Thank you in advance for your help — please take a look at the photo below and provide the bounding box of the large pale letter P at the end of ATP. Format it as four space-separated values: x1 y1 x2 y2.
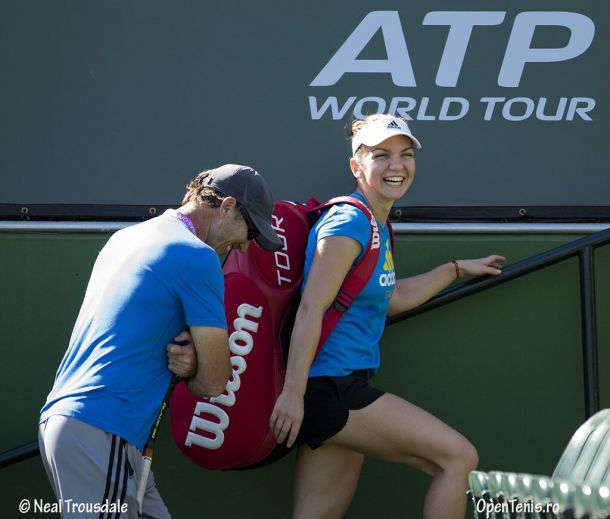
498 11 595 87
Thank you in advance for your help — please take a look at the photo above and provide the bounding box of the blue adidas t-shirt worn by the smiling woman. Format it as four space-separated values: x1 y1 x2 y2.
304 193 396 377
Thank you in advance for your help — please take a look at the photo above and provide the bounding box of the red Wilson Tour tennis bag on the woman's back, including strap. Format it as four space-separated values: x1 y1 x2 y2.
170 197 380 470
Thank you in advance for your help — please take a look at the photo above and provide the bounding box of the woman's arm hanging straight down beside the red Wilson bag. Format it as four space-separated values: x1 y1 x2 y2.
269 236 362 447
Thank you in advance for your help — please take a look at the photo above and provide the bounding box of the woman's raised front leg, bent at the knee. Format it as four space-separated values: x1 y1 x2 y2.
325 393 478 519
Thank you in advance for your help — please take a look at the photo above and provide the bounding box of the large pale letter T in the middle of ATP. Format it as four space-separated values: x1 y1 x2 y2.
423 11 506 87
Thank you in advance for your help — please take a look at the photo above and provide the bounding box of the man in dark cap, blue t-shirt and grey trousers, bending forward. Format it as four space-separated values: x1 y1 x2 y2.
39 164 281 518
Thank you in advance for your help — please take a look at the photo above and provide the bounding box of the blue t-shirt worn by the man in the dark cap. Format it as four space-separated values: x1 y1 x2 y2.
40 214 227 449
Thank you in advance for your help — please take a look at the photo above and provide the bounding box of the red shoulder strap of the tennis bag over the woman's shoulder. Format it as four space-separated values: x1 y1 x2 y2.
311 196 381 354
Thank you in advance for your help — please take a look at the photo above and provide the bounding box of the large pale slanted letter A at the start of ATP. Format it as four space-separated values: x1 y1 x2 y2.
310 11 416 87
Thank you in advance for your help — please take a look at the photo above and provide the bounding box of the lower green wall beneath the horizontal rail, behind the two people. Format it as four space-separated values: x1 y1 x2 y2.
0 233 610 519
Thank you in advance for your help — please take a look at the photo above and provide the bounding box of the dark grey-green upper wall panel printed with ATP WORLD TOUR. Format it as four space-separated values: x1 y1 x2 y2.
0 0 610 207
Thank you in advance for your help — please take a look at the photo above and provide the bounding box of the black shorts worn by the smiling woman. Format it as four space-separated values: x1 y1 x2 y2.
297 370 384 449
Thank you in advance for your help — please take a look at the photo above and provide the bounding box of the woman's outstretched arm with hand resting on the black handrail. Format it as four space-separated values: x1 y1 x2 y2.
388 254 506 315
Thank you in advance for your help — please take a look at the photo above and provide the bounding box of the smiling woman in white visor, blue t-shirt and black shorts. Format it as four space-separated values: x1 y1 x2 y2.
270 114 505 519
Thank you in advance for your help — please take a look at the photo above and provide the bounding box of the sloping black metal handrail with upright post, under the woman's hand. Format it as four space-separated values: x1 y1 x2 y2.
0 229 610 469
